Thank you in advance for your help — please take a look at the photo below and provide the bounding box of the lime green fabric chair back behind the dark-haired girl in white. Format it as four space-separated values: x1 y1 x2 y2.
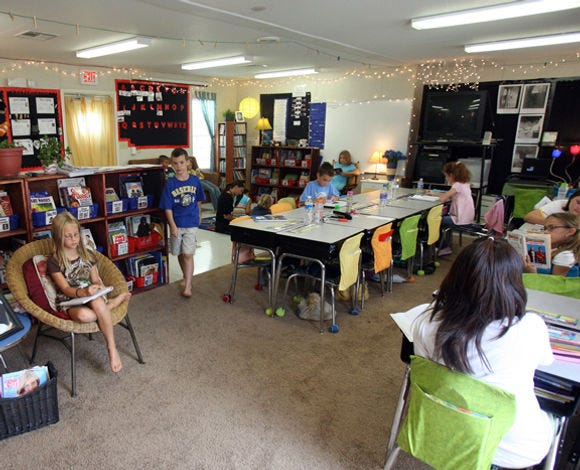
397 356 516 470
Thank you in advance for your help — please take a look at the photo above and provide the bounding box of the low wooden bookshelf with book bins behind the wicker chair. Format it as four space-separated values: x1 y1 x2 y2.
0 167 169 292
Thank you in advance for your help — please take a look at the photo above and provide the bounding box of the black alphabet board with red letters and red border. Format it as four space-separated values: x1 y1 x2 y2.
115 80 190 148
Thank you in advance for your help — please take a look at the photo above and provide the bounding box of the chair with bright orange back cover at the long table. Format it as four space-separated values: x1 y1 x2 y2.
361 223 394 310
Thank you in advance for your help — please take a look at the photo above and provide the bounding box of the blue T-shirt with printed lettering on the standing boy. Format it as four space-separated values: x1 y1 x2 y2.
159 175 205 228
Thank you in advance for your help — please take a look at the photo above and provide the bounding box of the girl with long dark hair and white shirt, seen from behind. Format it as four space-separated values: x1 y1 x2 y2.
412 238 554 468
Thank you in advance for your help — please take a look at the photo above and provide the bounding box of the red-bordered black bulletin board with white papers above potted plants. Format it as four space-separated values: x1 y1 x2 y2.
0 88 63 168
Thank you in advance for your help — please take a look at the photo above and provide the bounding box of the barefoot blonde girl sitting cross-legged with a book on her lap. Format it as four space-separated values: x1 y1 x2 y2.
47 211 131 372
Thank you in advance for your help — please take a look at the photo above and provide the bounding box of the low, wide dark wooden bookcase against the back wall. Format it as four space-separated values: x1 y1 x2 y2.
250 146 320 199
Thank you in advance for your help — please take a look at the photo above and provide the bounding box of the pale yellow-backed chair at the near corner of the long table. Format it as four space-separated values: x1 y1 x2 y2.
276 233 363 333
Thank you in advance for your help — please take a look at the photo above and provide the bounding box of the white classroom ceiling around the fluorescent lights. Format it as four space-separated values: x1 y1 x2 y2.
0 0 580 78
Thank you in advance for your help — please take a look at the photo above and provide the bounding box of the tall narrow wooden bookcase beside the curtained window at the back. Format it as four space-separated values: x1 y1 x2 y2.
215 121 248 183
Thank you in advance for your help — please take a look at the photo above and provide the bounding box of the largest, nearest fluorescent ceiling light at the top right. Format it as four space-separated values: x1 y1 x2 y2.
411 0 580 29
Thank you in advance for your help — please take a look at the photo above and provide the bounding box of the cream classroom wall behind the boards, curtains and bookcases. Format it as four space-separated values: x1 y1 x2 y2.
0 61 578 171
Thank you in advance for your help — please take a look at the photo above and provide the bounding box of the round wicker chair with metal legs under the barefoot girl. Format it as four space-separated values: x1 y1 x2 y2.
6 239 144 397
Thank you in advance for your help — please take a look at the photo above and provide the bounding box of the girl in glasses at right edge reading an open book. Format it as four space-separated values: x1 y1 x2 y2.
524 212 580 277
